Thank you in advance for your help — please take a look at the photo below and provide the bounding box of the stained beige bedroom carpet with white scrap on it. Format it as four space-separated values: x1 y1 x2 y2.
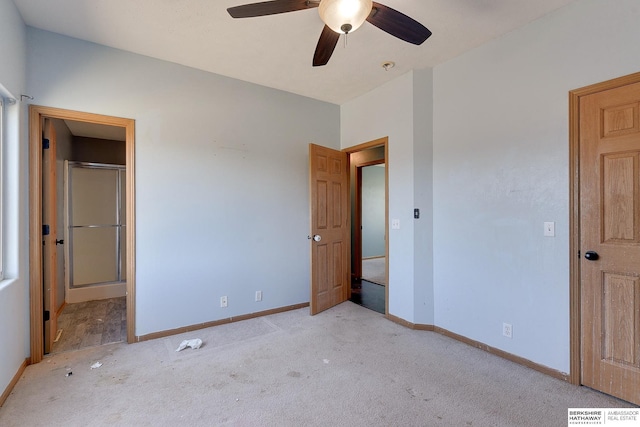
0 302 631 427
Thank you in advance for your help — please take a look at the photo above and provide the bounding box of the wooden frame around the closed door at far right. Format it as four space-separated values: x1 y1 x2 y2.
569 72 640 385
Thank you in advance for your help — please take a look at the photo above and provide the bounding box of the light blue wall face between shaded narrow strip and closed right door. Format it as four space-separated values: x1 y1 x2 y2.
434 0 640 372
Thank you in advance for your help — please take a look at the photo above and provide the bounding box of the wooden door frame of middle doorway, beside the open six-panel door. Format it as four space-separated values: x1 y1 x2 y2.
342 136 389 317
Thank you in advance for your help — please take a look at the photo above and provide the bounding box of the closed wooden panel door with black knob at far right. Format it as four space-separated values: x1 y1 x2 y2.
580 79 640 404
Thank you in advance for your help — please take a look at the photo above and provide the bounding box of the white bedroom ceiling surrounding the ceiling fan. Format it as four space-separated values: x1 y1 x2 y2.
14 0 574 104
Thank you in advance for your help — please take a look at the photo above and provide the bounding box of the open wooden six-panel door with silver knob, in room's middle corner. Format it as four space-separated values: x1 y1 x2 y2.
309 144 351 315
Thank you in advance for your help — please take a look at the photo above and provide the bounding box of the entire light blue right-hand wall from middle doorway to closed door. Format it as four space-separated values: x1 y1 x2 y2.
341 0 640 372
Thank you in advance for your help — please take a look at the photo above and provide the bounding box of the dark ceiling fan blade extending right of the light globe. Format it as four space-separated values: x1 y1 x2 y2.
367 2 431 44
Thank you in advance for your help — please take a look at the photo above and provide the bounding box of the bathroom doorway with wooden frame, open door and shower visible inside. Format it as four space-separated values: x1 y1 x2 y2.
29 106 135 363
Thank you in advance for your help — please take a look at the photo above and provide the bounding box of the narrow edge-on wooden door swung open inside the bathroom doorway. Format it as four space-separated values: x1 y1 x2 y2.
42 119 58 354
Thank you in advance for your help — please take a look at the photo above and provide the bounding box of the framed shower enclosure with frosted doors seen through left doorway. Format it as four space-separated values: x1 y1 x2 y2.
64 161 126 303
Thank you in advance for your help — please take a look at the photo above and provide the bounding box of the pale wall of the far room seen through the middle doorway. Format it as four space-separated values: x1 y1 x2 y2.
361 165 386 258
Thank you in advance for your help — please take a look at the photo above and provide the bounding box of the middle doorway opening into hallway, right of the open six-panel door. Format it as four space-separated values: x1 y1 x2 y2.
346 138 388 314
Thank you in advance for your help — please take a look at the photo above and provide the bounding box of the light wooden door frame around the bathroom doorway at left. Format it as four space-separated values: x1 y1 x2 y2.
29 105 136 364
